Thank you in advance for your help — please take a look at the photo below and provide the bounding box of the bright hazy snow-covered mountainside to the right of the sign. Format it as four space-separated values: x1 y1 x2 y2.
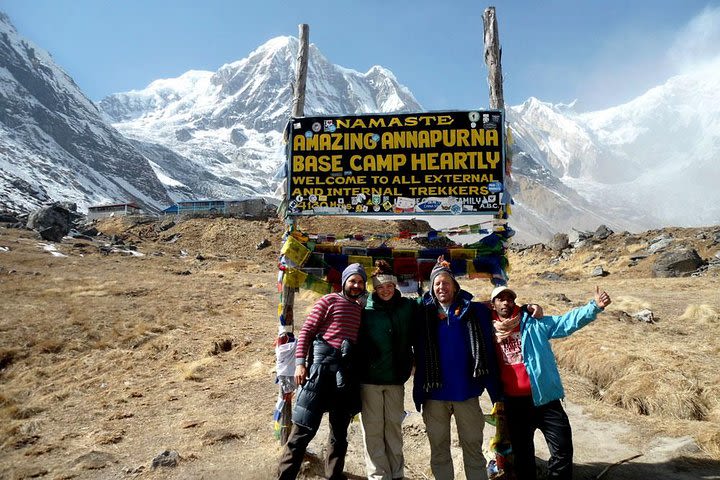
508 61 720 228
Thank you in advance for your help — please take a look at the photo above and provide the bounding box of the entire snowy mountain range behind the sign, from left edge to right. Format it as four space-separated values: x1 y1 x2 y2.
0 10 720 241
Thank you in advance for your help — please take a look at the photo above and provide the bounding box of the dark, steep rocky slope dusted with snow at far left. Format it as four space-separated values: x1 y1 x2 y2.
0 13 170 210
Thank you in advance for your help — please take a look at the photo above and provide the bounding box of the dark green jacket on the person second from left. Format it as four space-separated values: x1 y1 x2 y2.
357 290 418 385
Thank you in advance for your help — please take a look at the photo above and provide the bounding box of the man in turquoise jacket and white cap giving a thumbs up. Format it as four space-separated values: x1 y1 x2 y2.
490 286 611 480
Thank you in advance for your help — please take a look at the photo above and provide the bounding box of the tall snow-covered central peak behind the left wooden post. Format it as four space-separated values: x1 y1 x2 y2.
100 37 421 196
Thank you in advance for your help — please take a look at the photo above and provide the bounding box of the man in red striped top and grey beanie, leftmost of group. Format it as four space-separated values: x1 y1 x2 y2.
278 263 367 480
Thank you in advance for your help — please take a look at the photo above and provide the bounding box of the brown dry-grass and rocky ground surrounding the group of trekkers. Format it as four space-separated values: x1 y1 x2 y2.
0 218 720 479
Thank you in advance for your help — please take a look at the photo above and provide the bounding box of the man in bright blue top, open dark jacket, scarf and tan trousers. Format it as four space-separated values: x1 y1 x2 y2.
413 257 500 480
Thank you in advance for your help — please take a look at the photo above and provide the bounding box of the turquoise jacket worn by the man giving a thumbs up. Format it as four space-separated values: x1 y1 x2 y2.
520 300 602 406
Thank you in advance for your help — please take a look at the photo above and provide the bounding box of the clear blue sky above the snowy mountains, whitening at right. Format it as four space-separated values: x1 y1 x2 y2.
0 0 720 111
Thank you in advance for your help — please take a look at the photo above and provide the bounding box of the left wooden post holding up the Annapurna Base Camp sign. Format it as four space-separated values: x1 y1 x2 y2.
278 23 310 445
